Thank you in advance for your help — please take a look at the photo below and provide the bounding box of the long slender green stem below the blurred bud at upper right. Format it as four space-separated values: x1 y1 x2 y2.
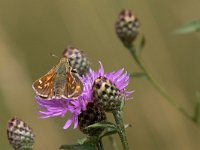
125 45 193 120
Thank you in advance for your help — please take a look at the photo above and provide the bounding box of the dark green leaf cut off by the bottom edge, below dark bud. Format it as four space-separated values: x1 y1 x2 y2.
60 144 97 150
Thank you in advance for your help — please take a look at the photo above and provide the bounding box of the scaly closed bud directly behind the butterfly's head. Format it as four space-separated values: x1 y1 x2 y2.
63 47 90 76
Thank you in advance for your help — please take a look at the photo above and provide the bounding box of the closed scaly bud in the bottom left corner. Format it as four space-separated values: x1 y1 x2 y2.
7 117 35 150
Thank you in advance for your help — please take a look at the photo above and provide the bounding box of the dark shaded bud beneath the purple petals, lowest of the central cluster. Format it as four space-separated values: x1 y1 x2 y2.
78 103 106 136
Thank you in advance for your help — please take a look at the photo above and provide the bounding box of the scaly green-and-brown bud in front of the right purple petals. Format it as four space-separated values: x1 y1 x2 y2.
92 77 123 112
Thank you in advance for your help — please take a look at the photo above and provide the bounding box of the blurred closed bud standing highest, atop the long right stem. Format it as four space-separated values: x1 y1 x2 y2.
115 9 140 45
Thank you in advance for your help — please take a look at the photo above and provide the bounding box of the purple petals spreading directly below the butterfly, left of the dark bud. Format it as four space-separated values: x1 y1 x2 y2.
35 95 89 129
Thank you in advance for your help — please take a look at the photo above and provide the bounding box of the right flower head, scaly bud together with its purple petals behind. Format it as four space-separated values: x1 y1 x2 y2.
84 63 132 112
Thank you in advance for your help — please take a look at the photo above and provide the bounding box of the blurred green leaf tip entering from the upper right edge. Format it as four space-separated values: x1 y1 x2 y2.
175 20 200 34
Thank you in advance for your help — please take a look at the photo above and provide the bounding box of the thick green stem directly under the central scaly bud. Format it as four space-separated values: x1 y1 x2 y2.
112 110 129 150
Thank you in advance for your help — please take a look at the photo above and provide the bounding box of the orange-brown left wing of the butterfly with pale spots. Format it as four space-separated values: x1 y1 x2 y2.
32 67 56 99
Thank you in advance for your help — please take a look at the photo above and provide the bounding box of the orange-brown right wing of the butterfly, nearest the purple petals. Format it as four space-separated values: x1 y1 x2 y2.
63 72 83 98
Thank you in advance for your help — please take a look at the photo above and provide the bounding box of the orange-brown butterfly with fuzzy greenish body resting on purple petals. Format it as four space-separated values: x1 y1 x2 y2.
32 57 83 100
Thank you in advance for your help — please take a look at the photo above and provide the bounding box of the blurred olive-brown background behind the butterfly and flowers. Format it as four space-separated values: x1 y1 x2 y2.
0 0 200 150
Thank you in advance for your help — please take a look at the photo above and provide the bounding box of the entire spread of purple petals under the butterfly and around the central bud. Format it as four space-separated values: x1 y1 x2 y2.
35 63 132 129
